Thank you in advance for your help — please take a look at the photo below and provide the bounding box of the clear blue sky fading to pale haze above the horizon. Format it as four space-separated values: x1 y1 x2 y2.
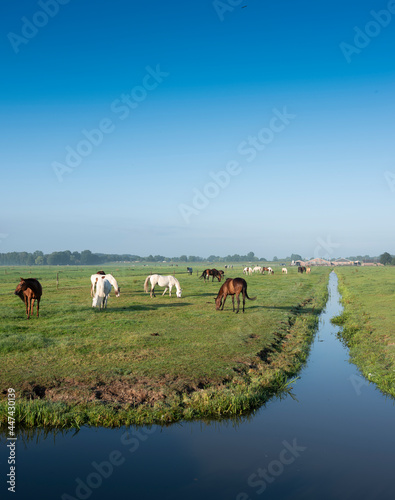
0 0 395 258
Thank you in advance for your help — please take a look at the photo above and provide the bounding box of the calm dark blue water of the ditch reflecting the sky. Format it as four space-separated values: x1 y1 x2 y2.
0 273 395 500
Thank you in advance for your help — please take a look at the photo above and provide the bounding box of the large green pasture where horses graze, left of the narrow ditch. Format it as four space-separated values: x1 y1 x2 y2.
0 266 329 427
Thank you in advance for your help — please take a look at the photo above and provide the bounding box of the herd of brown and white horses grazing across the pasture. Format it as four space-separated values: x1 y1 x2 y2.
14 266 311 319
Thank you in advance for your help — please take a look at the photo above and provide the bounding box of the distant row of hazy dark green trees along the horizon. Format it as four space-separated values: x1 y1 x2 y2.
0 250 395 266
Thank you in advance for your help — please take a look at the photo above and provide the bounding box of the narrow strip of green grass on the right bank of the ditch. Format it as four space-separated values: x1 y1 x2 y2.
332 266 395 397
